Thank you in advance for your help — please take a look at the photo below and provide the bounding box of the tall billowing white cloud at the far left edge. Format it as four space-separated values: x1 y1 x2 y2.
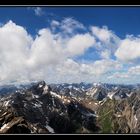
0 21 32 81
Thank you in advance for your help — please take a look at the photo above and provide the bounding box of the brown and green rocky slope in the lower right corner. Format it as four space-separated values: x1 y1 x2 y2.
98 93 140 133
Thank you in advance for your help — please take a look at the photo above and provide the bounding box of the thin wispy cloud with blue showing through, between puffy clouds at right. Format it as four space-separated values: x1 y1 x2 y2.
90 26 121 59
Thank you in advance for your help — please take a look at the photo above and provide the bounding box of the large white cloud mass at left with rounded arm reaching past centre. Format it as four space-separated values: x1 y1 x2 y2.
0 21 95 83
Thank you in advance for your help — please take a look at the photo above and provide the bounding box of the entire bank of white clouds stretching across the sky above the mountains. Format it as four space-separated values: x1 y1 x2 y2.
0 18 140 84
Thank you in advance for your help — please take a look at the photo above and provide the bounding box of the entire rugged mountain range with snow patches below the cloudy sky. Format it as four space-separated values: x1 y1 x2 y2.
0 81 140 134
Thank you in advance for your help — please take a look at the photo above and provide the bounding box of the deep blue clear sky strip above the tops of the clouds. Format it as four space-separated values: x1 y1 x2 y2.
0 7 140 37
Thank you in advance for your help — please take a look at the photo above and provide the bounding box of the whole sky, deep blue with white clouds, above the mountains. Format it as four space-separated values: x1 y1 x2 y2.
0 7 140 84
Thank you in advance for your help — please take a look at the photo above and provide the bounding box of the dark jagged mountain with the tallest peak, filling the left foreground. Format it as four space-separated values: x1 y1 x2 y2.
0 81 99 134
